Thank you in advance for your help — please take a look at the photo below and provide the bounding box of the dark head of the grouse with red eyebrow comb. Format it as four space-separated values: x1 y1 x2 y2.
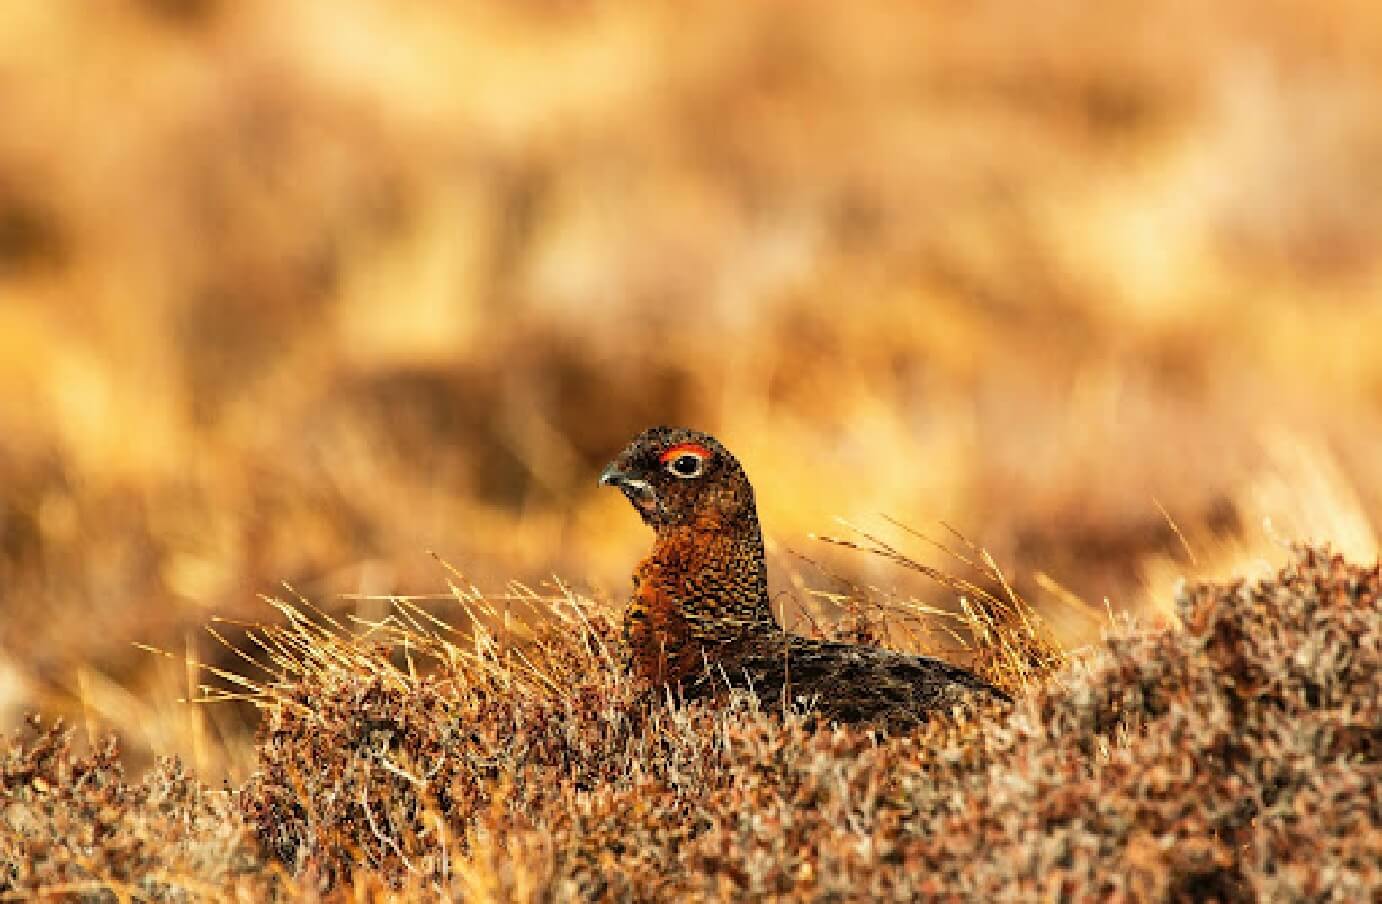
600 427 756 531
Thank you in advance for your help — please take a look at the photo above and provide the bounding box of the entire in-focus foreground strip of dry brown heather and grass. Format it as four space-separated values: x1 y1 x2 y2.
0 550 1382 901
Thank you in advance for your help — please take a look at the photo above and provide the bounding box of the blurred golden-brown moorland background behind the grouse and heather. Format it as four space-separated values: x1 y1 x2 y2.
0 0 1382 774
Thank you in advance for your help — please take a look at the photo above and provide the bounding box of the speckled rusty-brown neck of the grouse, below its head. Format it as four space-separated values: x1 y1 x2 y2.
650 513 781 644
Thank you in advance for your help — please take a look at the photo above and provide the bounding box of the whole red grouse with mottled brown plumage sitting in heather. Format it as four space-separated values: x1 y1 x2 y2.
600 427 1006 727
